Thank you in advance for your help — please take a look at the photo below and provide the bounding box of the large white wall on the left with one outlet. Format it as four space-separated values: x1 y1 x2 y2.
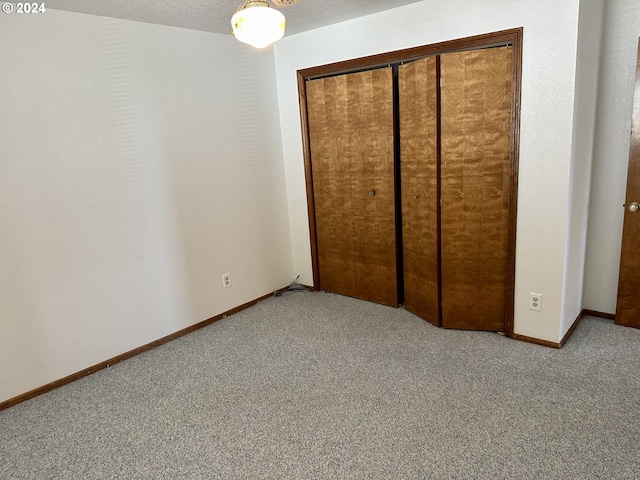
0 10 293 401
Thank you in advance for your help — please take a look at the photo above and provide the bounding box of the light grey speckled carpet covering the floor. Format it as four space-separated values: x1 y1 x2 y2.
0 292 640 479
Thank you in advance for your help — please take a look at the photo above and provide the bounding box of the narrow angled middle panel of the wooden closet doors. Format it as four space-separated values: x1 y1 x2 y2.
398 57 440 325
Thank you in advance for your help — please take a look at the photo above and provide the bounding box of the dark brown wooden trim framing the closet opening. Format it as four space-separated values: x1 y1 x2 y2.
297 27 523 337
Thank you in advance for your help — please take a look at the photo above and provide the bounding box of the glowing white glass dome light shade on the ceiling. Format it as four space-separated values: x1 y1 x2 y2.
231 0 285 48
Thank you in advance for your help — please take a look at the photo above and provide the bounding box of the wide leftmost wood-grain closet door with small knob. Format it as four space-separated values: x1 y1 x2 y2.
306 68 398 306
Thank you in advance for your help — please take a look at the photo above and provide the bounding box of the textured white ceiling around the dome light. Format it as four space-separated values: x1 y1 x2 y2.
46 0 420 35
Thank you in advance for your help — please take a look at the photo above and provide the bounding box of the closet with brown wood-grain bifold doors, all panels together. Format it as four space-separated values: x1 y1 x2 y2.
299 30 521 333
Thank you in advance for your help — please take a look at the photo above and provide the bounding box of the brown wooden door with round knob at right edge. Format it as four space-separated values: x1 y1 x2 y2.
616 41 640 328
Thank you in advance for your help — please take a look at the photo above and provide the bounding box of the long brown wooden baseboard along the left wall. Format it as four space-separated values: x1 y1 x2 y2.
0 292 275 411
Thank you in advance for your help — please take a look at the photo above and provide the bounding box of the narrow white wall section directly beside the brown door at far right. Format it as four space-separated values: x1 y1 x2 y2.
583 0 640 313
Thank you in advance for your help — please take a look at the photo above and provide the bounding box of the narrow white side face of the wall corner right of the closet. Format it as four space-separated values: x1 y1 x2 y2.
560 0 604 338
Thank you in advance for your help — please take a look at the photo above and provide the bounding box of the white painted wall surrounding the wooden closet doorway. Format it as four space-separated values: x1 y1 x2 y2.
275 0 579 342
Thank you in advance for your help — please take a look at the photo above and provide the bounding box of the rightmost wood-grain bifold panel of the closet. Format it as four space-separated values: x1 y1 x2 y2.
441 47 512 331
